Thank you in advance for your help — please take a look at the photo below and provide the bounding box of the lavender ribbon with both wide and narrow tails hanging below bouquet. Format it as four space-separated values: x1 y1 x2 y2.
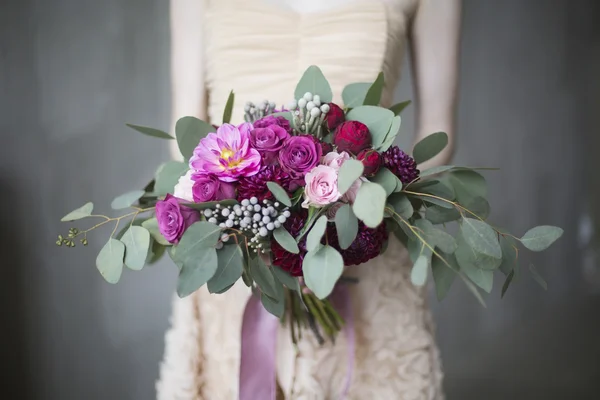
239 284 355 400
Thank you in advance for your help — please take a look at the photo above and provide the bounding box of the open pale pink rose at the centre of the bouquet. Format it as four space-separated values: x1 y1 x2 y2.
302 165 341 208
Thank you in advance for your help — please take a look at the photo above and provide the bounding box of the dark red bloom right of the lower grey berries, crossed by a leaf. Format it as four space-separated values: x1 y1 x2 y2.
271 208 308 276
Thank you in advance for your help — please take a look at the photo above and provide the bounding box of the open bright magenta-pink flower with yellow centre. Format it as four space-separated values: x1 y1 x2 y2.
190 123 261 182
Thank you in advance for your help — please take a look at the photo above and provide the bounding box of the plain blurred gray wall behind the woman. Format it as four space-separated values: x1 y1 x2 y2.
0 0 600 400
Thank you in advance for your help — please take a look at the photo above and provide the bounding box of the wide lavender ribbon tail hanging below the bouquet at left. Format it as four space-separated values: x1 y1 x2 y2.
239 294 279 400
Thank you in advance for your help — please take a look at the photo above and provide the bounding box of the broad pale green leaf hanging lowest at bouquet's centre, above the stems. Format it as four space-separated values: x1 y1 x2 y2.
302 246 344 299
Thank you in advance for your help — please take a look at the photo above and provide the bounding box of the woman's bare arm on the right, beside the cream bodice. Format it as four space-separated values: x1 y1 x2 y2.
410 0 461 169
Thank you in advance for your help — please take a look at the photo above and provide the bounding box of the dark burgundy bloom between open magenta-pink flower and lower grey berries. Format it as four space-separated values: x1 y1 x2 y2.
237 165 296 201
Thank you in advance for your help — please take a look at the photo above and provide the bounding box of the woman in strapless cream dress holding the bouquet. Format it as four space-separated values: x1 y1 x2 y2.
157 0 460 400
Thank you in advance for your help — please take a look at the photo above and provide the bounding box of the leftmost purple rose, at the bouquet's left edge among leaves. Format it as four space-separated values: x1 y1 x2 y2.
156 194 200 243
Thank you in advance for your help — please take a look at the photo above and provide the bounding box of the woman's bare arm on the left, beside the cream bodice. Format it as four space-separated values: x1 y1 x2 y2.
170 0 206 159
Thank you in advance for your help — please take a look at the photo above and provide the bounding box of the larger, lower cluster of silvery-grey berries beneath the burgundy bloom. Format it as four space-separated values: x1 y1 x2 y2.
204 197 291 252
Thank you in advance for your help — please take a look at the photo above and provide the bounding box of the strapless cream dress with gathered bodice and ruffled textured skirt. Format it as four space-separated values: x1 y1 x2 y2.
157 0 443 400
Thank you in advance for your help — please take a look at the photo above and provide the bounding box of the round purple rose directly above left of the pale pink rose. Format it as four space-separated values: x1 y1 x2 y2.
279 135 323 180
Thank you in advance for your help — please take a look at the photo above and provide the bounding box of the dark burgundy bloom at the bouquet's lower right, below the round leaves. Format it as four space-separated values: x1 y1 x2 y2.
327 222 388 266
